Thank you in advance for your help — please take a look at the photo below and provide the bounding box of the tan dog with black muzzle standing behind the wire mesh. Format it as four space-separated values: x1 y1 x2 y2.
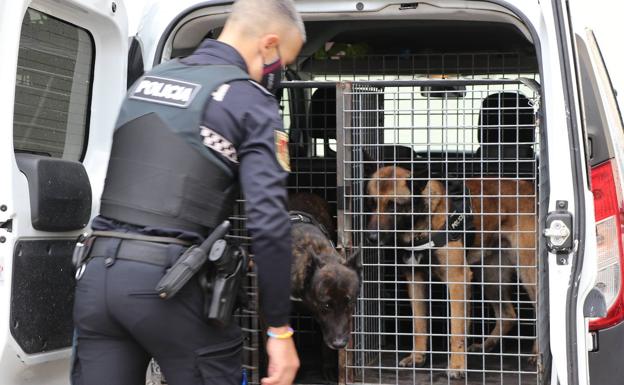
367 166 537 379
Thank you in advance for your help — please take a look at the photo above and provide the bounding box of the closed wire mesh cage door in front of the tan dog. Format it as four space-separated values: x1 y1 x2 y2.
337 79 544 385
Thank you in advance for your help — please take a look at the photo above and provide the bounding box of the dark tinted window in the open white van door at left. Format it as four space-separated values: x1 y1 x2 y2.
13 9 94 161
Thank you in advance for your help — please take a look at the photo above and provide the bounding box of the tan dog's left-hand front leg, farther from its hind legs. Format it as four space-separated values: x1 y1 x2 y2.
399 270 429 367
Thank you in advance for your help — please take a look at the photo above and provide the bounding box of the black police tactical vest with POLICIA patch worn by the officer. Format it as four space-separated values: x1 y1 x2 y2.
100 60 249 236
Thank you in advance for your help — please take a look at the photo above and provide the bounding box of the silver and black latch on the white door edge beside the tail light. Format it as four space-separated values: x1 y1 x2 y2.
543 201 573 265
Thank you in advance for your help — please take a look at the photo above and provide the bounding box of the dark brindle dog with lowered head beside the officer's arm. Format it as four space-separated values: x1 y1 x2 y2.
288 193 361 350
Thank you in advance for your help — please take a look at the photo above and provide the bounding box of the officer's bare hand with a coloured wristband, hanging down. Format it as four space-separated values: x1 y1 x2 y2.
262 328 299 385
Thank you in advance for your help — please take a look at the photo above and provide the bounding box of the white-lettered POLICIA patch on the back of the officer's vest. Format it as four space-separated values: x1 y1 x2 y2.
130 76 201 108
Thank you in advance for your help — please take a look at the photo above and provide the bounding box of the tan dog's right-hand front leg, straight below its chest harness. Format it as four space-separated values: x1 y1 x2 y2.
437 241 472 379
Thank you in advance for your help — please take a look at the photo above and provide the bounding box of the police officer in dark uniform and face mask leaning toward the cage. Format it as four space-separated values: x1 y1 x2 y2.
72 0 305 385
